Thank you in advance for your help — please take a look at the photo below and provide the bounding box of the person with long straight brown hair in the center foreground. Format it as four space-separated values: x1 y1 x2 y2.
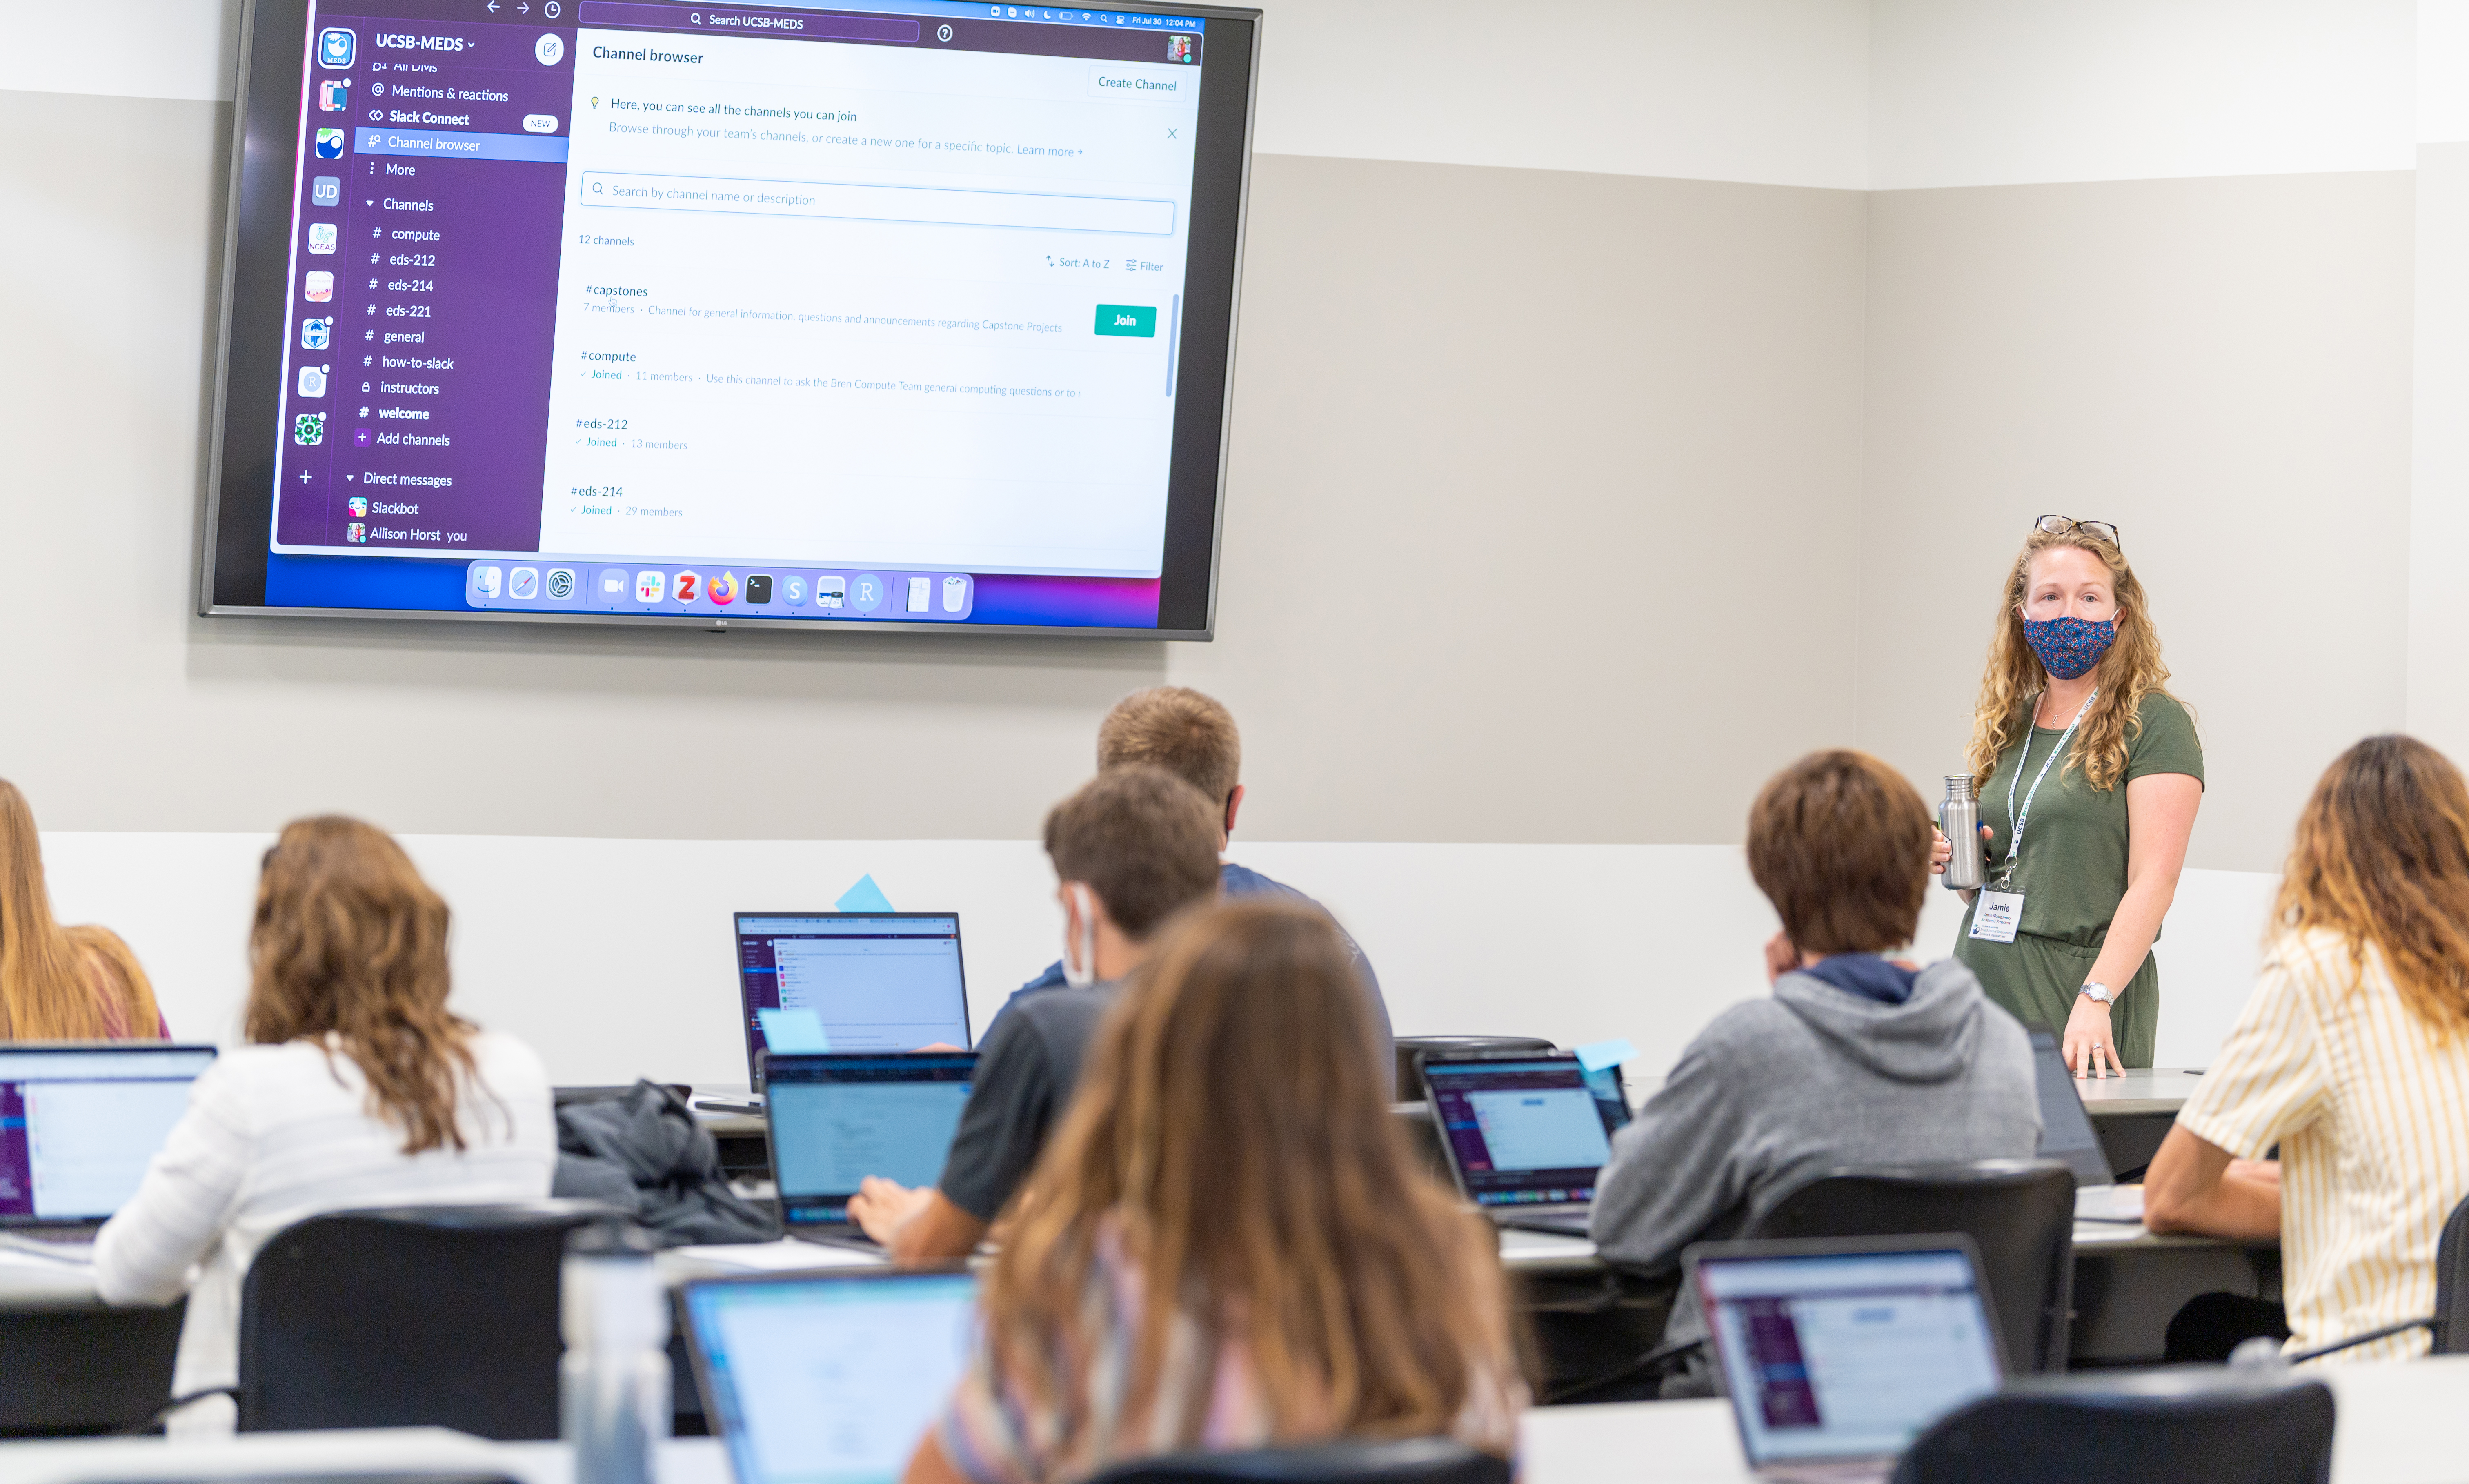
909 899 1526 1484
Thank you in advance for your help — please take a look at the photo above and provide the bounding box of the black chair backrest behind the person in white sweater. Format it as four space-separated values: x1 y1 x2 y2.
240 1200 622 1440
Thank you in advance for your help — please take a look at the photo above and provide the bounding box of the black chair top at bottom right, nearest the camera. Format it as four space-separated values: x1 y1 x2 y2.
1894 1366 2333 1484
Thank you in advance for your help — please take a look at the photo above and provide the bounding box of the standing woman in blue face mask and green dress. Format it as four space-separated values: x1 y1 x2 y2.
1941 516 2202 1077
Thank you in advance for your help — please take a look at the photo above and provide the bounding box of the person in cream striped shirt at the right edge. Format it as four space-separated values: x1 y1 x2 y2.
2143 736 2469 1361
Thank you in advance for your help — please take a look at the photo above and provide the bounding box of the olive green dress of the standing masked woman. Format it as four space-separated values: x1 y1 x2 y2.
1955 694 2202 1067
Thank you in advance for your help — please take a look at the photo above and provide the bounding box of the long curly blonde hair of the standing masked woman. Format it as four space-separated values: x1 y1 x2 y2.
1963 528 2168 792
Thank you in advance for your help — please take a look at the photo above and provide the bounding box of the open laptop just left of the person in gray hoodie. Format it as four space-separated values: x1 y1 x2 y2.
1422 1052 1630 1237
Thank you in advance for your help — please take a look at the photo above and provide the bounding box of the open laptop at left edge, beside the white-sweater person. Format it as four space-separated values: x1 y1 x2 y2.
0 1042 215 1242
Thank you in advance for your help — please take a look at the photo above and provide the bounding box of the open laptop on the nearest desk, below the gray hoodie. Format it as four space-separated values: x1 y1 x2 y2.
1682 1235 2005 1479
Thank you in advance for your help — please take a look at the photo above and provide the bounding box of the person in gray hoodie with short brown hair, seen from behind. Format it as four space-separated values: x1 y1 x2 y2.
1593 751 2040 1395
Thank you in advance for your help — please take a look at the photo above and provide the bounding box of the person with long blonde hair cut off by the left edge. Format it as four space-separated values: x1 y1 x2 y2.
0 778 163 1042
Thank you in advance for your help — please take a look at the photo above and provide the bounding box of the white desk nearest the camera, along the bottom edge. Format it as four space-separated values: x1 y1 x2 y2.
0 1355 2469 1484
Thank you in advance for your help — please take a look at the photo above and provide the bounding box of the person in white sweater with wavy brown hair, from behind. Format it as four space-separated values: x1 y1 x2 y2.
94 817 558 1435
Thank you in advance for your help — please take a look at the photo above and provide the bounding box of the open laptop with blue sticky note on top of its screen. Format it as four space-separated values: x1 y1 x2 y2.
736 911 973 1106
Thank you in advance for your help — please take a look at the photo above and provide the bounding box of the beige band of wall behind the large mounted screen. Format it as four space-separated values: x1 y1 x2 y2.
0 94 1864 842
